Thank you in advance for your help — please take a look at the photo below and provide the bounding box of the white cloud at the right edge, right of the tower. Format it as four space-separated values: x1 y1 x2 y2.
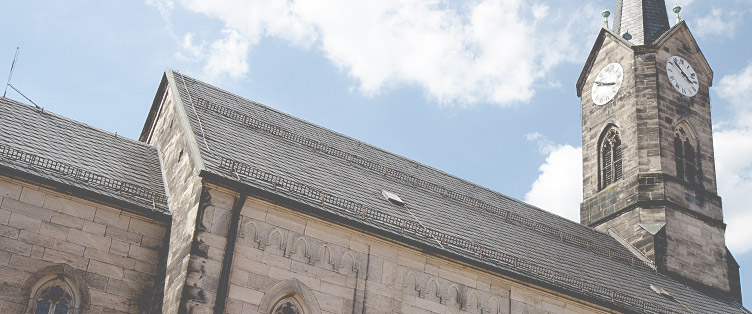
713 63 752 254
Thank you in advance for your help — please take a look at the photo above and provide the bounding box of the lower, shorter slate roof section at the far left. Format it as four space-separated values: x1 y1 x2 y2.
0 98 169 218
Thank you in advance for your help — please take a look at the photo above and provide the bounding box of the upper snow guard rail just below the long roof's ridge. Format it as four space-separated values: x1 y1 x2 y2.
196 98 654 271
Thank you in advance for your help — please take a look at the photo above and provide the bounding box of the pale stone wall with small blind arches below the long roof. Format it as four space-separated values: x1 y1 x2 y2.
217 194 602 314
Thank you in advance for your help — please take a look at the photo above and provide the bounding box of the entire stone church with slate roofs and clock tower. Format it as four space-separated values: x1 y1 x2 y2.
0 0 750 314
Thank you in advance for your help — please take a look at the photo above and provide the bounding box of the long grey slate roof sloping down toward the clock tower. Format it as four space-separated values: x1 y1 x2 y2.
166 71 749 313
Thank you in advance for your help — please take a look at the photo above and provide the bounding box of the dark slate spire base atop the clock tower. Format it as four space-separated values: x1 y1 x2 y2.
614 0 671 45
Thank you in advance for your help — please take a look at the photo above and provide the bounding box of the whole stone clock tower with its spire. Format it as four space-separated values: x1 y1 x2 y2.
577 0 741 299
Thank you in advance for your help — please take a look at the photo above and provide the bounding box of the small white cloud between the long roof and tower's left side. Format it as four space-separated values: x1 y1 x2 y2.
525 133 582 222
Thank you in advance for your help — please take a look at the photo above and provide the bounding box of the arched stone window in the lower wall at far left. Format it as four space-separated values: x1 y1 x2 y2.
22 264 89 314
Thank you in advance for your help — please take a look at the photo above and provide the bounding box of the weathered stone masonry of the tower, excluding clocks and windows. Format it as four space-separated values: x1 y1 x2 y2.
580 25 729 291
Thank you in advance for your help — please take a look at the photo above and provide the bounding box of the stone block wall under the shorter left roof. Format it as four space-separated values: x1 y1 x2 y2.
0 177 165 313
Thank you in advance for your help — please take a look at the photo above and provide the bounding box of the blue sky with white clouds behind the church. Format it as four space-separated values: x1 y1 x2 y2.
0 0 752 300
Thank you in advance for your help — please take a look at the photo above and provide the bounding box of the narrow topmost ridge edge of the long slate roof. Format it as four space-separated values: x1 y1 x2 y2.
177 73 600 232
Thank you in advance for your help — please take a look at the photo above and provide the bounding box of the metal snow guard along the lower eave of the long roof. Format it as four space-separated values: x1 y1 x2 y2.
220 156 679 314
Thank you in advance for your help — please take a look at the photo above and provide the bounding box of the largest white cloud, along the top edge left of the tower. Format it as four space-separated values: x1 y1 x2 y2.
156 0 600 106
